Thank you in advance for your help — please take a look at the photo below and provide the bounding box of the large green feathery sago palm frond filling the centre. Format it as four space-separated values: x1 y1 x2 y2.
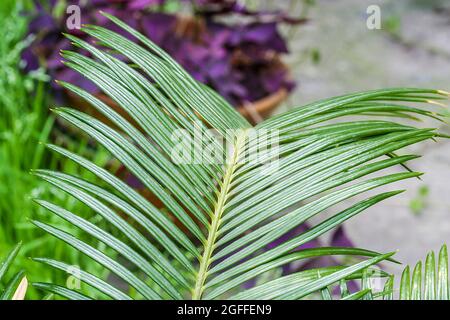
29 14 447 299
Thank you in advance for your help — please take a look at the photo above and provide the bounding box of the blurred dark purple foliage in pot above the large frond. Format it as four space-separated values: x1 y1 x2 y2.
23 0 303 105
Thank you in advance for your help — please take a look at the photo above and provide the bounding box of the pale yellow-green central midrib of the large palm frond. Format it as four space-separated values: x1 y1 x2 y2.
192 132 246 300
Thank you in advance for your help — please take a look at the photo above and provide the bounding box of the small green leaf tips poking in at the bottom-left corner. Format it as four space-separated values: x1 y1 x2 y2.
0 243 28 300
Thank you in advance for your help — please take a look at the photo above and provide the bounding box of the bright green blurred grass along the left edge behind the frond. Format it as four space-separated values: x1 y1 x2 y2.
0 1 116 298
